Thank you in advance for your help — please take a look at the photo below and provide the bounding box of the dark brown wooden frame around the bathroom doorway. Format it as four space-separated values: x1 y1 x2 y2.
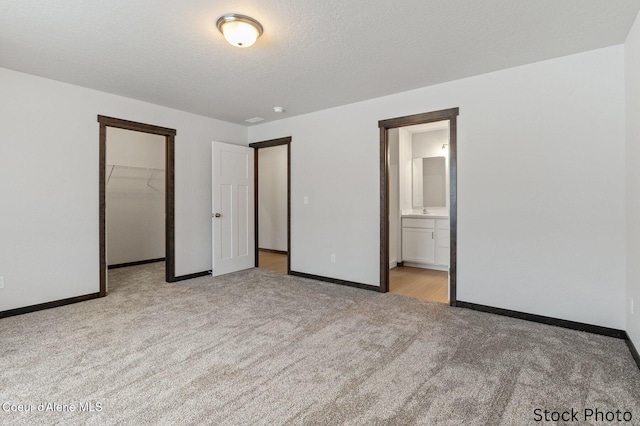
378 108 459 306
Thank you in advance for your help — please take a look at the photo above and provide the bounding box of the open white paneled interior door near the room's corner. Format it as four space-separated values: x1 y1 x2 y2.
211 142 255 276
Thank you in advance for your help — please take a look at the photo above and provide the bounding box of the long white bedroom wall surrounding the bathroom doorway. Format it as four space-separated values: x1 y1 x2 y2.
249 46 625 329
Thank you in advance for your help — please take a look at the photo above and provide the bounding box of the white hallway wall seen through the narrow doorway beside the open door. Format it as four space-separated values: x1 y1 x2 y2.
258 145 288 251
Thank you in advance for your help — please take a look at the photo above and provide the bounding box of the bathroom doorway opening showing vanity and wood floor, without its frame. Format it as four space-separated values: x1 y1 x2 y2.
388 120 450 303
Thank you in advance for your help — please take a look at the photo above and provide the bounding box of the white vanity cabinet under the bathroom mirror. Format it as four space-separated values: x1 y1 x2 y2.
402 217 449 270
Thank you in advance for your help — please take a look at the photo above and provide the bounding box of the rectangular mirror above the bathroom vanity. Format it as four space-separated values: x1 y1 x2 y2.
413 157 447 208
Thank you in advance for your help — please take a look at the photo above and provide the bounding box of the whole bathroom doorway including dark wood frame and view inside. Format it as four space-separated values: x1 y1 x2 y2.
379 108 458 306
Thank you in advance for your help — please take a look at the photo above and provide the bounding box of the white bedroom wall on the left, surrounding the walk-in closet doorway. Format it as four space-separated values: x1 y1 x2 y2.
0 69 247 311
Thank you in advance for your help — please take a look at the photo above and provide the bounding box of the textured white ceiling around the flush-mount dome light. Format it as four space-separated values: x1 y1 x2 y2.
0 0 640 124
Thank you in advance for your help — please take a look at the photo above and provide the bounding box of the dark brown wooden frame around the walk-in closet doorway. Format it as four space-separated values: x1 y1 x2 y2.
98 115 176 297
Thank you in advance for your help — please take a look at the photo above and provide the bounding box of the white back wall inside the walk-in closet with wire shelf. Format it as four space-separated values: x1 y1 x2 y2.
106 127 165 265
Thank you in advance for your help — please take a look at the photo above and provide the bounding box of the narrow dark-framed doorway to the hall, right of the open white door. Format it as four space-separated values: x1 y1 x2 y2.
249 137 291 274
